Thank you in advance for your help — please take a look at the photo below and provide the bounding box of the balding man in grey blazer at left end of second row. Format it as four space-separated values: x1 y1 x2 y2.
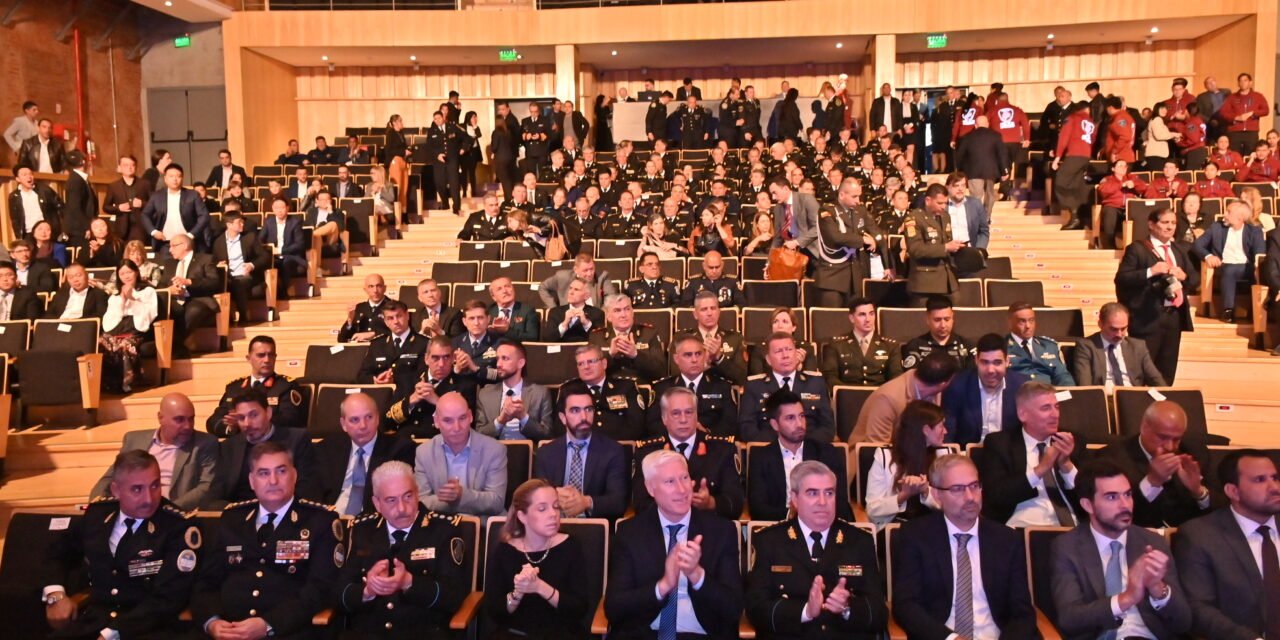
90 393 221 511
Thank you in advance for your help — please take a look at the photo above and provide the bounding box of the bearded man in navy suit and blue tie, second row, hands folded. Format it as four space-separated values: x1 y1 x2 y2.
534 383 630 520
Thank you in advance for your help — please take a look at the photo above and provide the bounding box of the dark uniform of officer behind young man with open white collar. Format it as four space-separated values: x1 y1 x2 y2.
737 370 836 443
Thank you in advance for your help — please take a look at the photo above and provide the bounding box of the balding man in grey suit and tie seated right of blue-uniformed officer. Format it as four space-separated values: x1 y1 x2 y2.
1071 302 1166 387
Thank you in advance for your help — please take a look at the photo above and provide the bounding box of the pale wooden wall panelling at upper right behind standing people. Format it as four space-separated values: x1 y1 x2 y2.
893 40 1199 111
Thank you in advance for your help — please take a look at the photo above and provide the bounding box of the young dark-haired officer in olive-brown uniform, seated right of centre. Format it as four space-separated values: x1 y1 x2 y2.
822 297 902 387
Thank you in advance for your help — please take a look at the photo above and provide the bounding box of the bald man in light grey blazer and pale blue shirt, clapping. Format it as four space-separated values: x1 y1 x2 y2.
413 392 507 516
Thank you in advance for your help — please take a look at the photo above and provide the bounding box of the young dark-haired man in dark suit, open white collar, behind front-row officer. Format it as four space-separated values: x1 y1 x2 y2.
746 390 854 521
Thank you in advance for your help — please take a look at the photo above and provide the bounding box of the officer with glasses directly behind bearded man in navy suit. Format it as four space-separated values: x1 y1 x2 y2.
556 344 645 440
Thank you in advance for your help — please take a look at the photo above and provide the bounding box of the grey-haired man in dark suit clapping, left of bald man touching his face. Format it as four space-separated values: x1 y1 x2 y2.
982 381 1085 527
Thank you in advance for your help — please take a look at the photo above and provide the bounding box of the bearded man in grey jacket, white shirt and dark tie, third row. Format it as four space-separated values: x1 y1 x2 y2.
476 338 552 440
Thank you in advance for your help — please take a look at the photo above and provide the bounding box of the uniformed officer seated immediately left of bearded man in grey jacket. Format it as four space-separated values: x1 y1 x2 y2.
383 337 476 438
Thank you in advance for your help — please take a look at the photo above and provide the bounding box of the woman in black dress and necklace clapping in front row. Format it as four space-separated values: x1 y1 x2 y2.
484 479 589 640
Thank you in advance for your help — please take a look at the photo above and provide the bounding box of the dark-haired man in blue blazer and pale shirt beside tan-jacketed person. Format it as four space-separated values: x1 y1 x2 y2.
942 333 1029 448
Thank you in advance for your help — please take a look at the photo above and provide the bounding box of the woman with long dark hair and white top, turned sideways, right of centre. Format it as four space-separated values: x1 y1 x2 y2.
865 401 947 531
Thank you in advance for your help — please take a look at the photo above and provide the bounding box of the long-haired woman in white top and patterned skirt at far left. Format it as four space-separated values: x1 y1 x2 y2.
99 260 160 393
